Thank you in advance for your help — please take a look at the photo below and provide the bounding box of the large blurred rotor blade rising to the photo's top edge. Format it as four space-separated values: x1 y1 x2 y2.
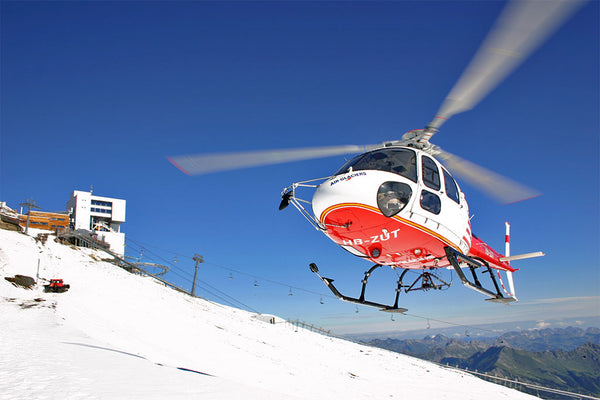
428 0 585 132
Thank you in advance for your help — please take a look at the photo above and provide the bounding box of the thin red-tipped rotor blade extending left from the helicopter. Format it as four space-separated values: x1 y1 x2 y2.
167 145 380 175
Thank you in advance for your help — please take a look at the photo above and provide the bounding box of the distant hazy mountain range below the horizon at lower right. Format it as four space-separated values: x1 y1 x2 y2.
369 327 600 396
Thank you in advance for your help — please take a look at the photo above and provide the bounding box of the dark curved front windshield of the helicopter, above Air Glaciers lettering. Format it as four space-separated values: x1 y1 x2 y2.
335 148 417 182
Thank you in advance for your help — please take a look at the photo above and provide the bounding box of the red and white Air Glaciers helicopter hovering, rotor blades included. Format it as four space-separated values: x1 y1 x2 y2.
168 0 584 313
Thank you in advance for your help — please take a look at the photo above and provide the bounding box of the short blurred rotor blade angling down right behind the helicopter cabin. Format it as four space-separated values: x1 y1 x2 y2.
438 149 541 204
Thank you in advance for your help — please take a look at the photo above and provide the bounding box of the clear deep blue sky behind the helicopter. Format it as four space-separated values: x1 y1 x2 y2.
0 1 600 333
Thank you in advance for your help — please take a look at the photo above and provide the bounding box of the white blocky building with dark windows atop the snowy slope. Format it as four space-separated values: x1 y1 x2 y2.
67 190 126 255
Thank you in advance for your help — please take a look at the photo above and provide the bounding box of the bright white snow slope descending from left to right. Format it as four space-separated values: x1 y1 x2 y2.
0 229 532 400
